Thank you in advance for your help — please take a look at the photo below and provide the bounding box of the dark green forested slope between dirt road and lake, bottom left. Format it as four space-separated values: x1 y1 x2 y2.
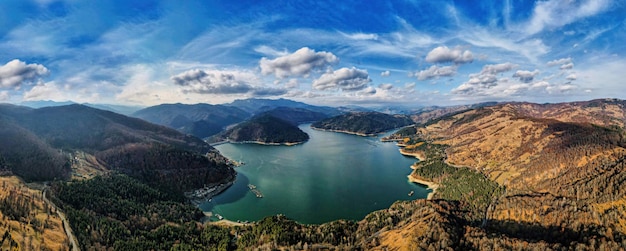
51 175 210 250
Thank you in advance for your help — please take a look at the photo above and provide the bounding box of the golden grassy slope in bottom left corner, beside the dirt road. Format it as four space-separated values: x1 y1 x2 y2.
0 176 70 250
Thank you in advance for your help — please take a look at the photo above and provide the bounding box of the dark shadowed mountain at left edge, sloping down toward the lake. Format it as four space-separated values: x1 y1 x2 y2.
0 104 235 191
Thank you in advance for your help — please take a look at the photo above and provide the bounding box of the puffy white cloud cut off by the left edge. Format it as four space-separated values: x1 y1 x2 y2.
0 59 48 88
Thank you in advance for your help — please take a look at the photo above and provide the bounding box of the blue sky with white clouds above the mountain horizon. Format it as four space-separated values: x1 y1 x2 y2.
0 0 626 106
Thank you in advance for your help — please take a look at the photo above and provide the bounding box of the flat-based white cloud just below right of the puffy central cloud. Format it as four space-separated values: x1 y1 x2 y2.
313 67 371 91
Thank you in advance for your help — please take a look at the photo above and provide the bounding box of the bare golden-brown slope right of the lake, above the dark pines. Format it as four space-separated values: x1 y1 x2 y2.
418 102 626 192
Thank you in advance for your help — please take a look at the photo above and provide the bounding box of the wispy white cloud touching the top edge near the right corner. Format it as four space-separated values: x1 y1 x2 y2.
522 0 611 35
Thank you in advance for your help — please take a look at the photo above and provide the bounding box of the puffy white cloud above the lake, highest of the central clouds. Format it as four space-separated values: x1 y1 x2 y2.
259 47 339 78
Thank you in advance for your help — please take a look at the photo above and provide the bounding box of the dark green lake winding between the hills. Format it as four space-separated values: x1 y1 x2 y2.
200 124 429 224
